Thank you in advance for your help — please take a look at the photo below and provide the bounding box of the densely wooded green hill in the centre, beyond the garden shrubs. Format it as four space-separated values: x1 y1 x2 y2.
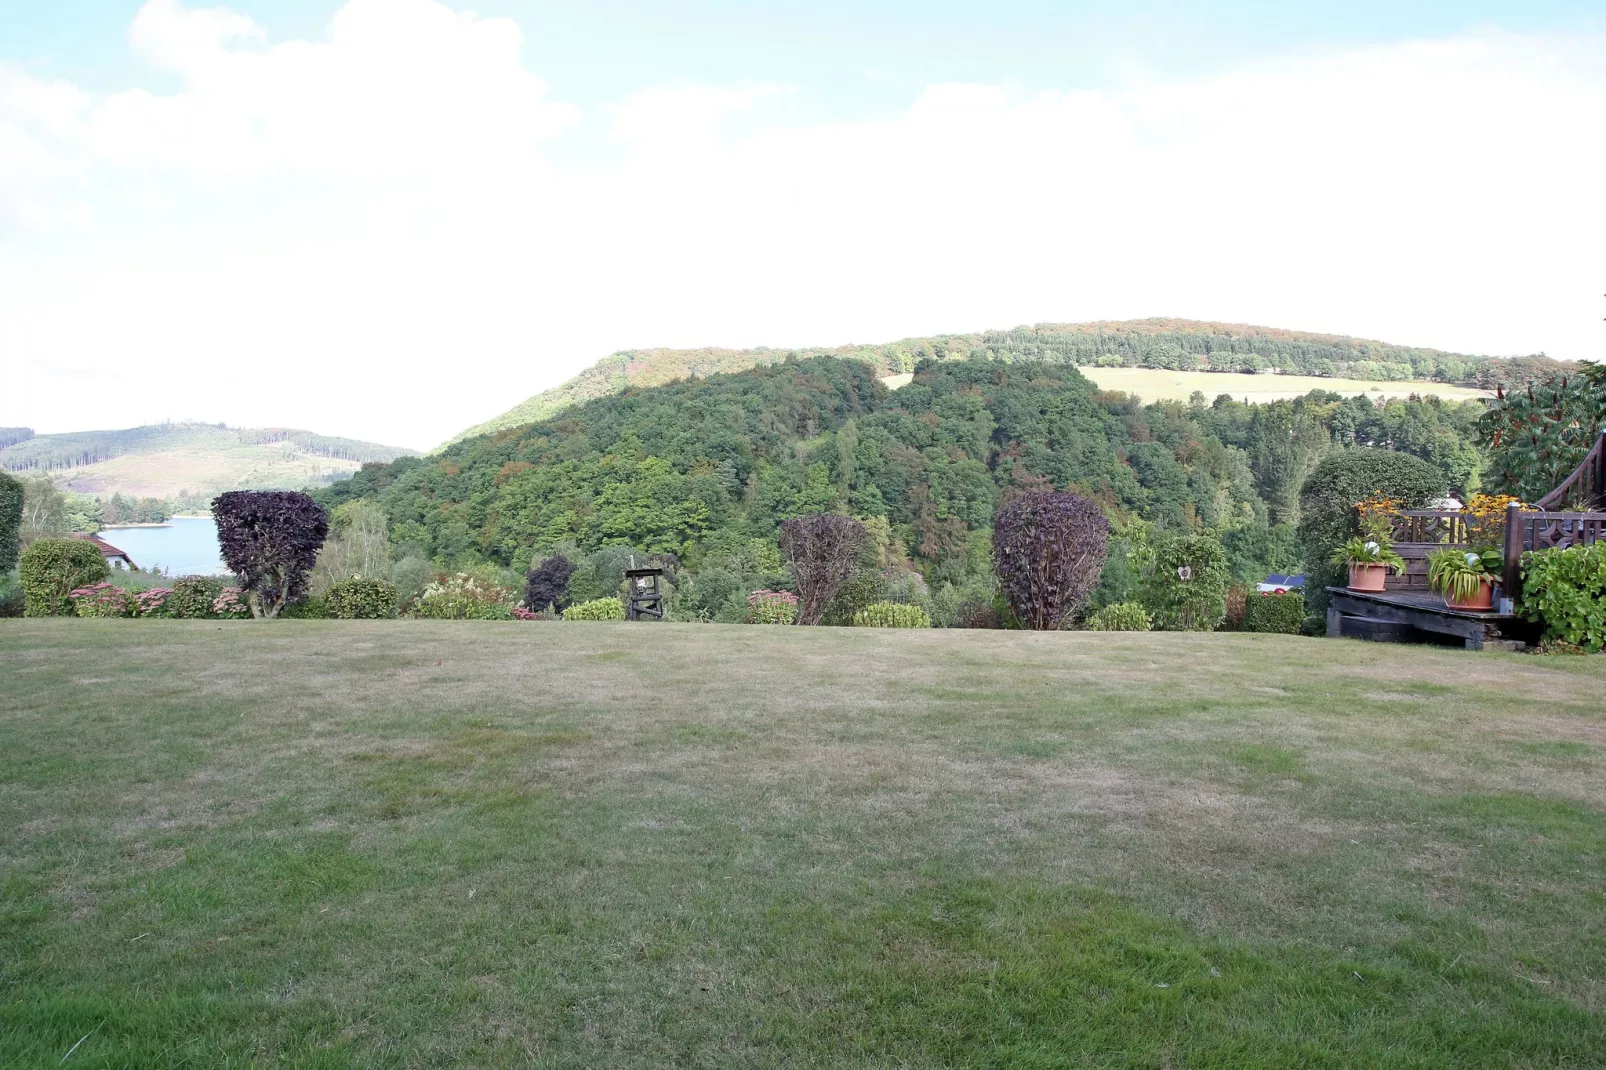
329 357 1482 582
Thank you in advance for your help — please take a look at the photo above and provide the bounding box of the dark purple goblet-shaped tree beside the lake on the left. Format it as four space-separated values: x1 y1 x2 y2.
212 490 329 619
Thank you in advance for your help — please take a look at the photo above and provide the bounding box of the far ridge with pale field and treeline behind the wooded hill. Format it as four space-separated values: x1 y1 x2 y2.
453 320 1556 442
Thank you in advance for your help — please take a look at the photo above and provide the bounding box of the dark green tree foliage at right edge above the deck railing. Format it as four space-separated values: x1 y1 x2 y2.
1478 365 1606 504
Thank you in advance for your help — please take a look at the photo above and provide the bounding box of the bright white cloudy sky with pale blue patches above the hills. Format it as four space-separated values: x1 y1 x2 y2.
0 0 1606 447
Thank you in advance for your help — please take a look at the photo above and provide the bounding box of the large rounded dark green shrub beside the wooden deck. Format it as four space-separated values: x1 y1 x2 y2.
1299 447 1449 617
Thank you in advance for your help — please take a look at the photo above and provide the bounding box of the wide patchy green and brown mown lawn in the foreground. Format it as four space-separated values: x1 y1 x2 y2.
0 620 1606 1070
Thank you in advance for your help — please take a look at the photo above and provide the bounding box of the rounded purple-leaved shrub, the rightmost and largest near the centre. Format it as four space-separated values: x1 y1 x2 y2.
993 490 1110 631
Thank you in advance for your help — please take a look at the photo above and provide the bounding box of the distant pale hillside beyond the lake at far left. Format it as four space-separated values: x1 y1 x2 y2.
0 424 413 498
